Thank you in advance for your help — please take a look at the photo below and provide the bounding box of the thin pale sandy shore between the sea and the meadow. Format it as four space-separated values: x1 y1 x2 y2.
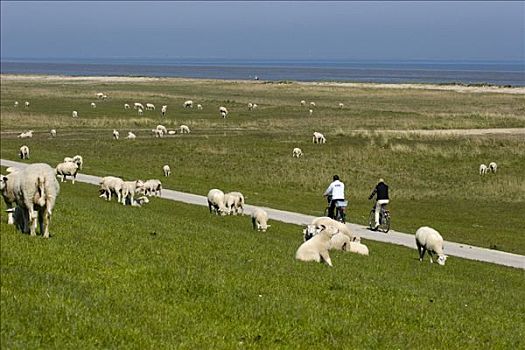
0 74 525 95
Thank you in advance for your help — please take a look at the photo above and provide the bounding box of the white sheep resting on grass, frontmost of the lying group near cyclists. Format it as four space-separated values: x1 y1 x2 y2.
295 225 339 267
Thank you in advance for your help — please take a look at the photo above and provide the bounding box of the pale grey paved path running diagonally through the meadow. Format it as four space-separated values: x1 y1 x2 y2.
0 159 525 269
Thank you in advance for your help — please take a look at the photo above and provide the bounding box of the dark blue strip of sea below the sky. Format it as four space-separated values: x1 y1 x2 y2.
0 58 525 86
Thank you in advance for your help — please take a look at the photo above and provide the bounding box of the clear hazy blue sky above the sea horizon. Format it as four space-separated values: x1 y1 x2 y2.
0 0 525 61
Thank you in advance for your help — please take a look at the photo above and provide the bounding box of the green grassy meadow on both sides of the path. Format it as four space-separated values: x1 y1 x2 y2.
0 79 525 349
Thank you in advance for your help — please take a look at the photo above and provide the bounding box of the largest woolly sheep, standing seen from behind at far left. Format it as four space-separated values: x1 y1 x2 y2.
14 163 60 238
